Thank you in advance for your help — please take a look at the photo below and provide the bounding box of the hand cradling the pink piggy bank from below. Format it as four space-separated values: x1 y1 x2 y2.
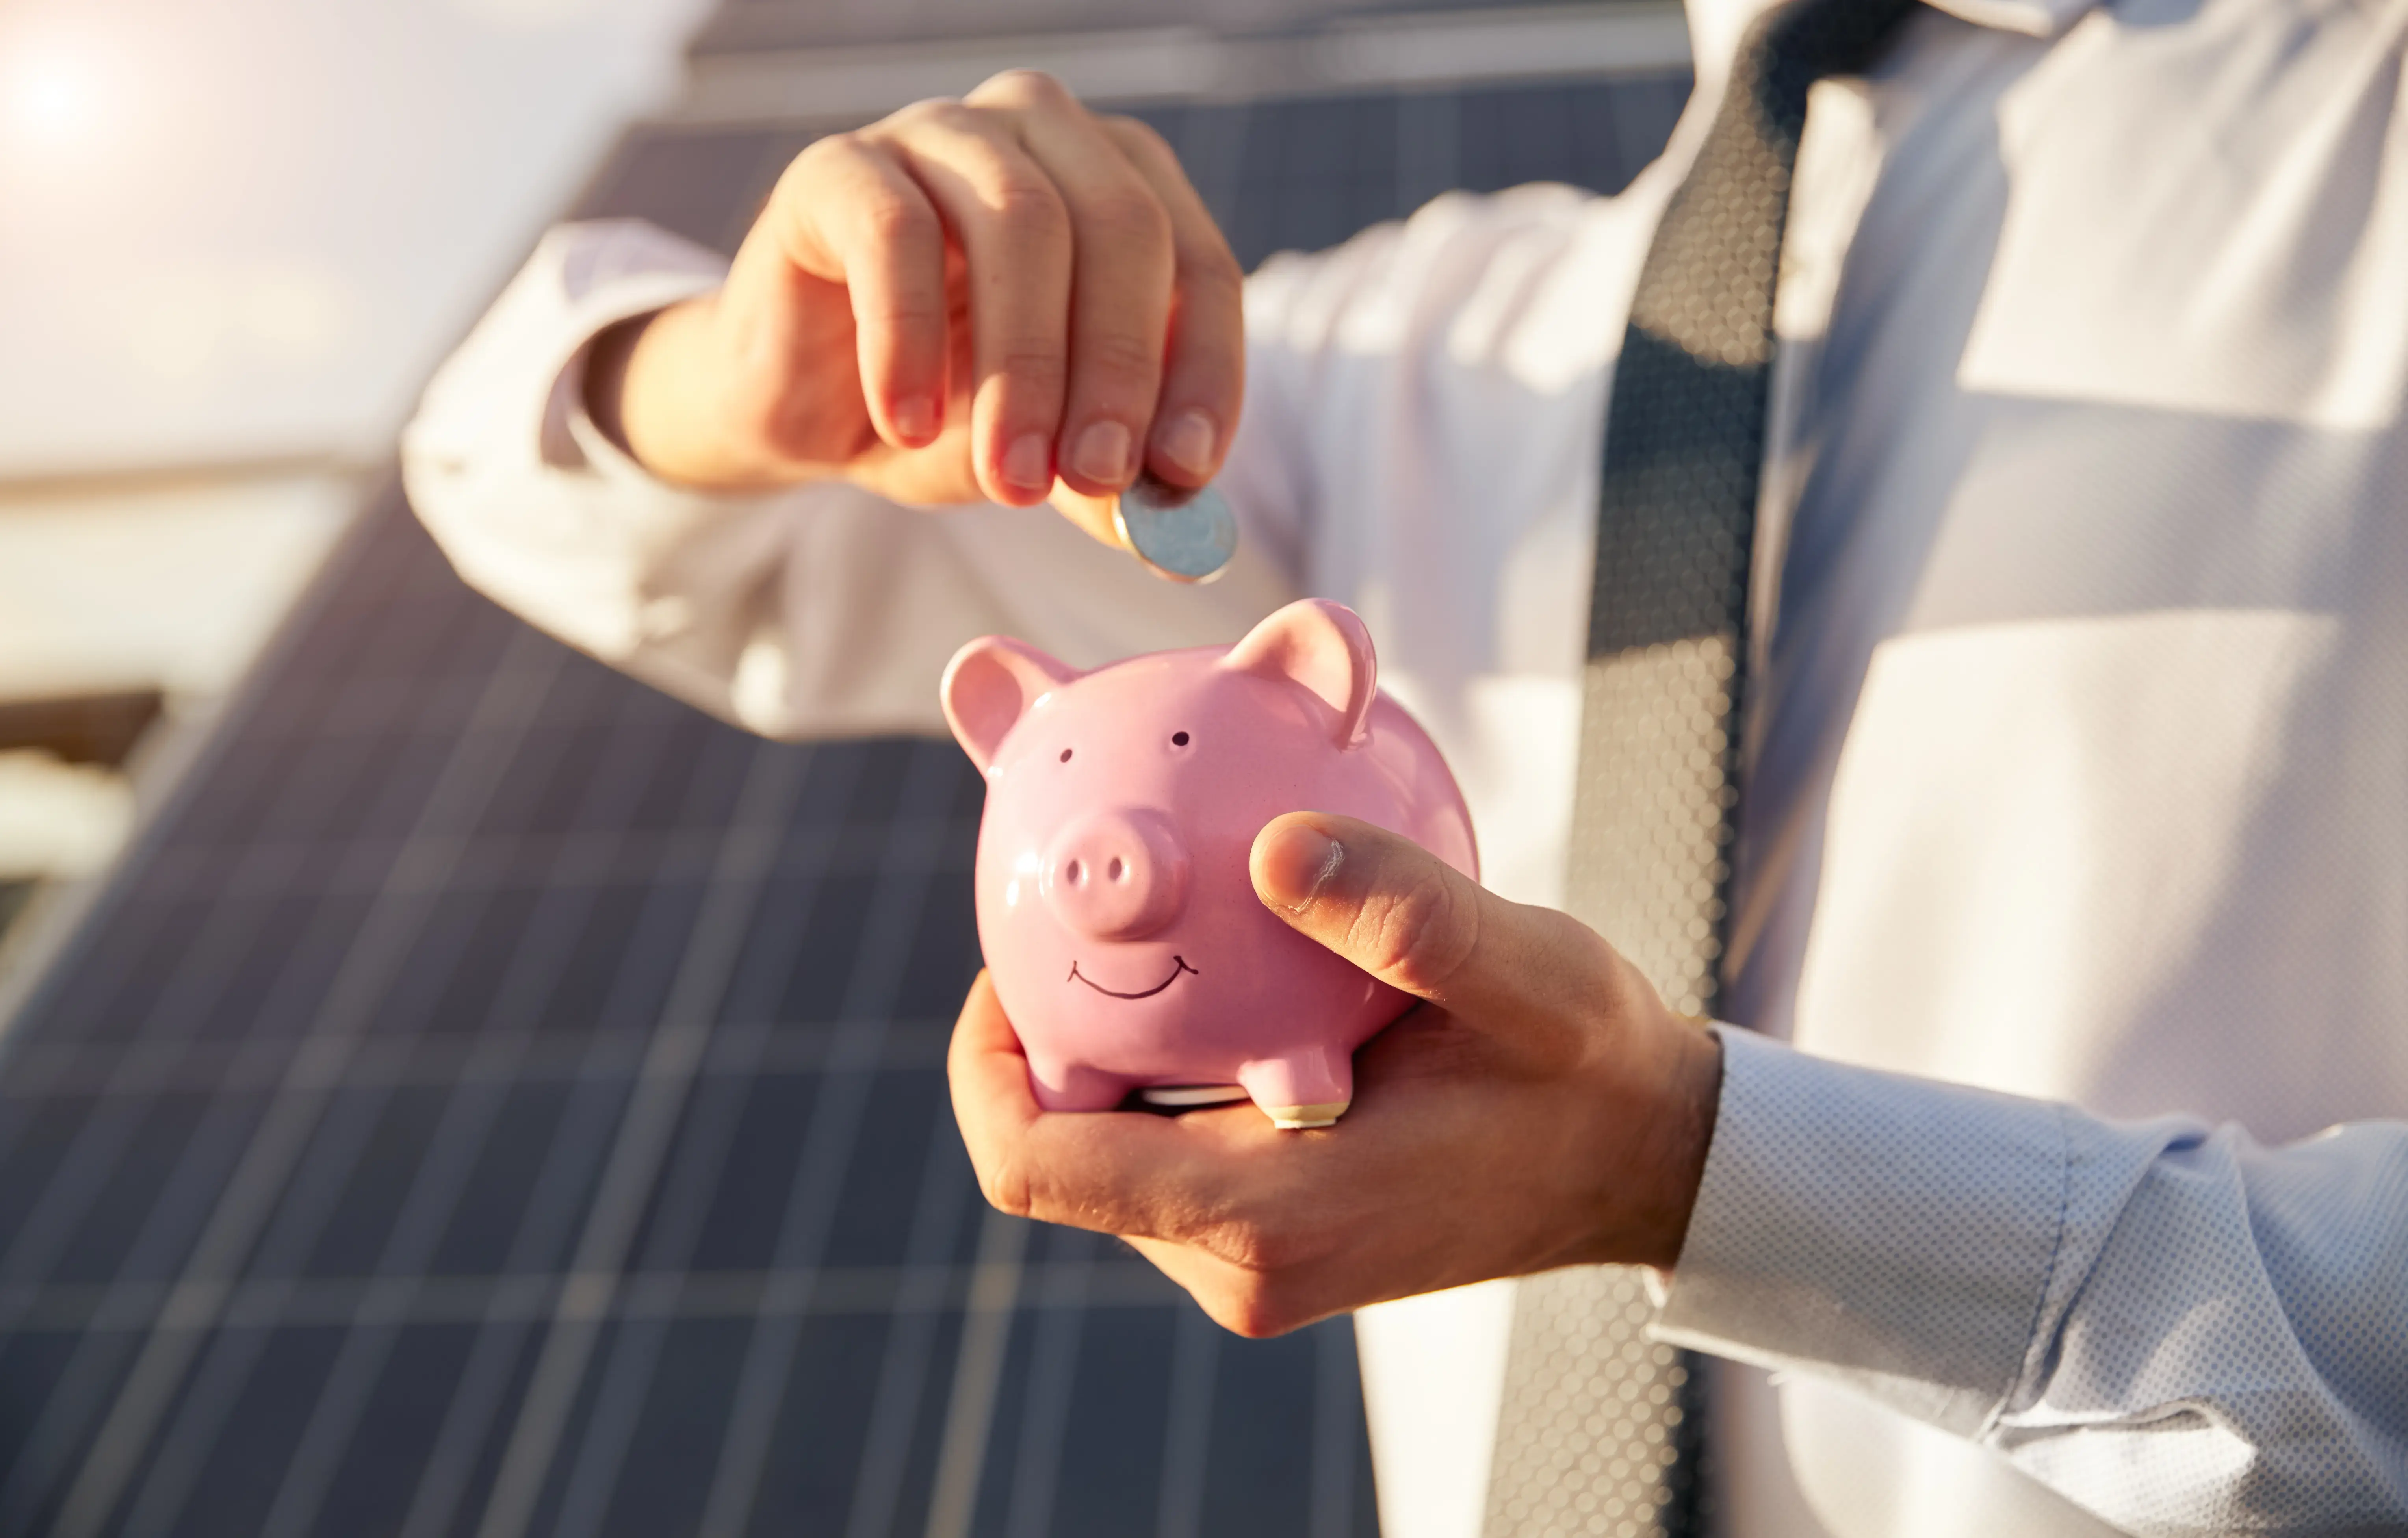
949 811 1722 1336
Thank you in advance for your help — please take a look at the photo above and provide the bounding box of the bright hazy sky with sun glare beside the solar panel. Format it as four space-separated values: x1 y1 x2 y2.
0 0 708 481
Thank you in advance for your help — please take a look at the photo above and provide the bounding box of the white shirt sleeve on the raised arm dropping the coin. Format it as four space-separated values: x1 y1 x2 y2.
402 219 1298 737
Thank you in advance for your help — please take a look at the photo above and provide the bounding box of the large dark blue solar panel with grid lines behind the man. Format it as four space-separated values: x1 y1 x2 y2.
0 57 1686 1538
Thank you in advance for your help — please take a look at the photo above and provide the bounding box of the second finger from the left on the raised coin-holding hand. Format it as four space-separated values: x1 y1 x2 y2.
889 101 1071 508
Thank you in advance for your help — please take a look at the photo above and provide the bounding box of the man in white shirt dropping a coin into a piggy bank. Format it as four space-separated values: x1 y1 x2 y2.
409 0 2408 1533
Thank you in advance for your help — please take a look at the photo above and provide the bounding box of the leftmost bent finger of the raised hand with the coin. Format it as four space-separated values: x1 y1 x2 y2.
761 135 949 448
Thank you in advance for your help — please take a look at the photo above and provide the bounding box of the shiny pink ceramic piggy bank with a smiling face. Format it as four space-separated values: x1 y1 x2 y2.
944 599 1478 1126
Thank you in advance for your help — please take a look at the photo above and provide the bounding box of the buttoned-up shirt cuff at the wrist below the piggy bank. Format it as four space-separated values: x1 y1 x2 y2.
1654 1028 2068 1434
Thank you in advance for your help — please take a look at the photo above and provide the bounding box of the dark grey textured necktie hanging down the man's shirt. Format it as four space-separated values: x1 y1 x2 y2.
1488 0 1914 1538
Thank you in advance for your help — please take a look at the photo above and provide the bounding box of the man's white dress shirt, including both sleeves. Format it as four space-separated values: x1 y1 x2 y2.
405 0 2408 1538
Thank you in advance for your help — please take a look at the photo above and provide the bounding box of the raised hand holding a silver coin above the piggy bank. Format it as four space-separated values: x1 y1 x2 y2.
588 70 1245 539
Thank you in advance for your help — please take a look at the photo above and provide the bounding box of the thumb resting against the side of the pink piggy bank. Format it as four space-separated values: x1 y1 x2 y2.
1250 811 1539 1016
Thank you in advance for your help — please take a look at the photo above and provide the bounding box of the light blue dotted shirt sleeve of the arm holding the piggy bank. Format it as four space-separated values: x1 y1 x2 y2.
1657 1030 2408 1536
